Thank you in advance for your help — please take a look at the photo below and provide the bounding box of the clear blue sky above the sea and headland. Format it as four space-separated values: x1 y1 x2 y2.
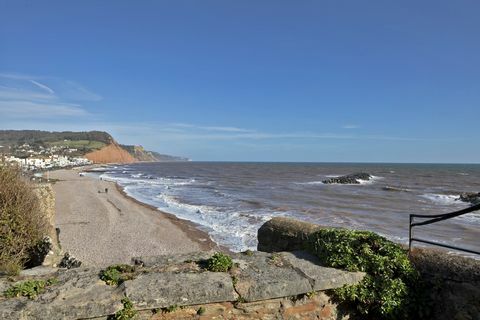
0 0 480 163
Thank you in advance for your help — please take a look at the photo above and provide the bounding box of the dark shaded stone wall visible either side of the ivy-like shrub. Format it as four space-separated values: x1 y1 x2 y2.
258 218 480 320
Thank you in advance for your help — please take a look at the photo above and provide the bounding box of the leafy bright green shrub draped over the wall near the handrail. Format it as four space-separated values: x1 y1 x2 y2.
309 229 418 319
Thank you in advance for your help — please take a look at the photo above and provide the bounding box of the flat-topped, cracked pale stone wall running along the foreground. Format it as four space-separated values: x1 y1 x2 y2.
0 251 365 320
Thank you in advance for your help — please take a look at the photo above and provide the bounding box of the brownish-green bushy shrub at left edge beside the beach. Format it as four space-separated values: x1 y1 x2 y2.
0 164 47 274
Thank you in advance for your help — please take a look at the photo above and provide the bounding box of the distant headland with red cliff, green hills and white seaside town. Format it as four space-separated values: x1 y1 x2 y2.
0 130 189 170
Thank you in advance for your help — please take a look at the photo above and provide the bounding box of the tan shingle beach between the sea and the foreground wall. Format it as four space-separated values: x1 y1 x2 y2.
50 170 217 266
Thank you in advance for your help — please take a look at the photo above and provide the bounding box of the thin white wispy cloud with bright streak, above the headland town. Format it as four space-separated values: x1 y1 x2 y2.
0 73 102 120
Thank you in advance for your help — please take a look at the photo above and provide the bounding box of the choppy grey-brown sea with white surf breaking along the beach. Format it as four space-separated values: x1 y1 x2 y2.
87 162 480 255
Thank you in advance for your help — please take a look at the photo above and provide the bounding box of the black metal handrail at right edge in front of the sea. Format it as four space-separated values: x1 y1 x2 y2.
408 203 480 255
